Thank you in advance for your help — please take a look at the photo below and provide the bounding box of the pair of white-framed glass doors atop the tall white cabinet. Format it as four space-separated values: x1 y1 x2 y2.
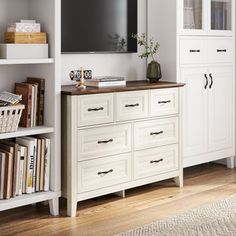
179 0 234 36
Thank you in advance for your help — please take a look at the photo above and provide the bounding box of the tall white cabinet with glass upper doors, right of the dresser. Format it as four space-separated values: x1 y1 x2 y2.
147 0 235 168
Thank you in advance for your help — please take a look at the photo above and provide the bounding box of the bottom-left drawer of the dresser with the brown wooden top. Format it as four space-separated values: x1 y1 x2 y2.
77 154 131 193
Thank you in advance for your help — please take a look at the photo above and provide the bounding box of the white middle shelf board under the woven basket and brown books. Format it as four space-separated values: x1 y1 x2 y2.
0 126 54 140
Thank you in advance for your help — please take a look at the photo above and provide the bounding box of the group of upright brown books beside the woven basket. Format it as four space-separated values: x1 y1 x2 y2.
15 78 45 128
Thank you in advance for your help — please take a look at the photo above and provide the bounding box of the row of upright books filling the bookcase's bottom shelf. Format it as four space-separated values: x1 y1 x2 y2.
0 137 51 199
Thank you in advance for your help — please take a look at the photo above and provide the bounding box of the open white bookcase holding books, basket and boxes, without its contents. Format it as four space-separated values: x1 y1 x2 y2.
0 0 61 215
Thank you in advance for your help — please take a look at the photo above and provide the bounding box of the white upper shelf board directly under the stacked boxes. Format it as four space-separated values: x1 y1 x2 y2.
0 58 54 65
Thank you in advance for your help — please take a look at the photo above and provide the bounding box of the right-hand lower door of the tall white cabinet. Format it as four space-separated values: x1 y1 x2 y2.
209 66 233 151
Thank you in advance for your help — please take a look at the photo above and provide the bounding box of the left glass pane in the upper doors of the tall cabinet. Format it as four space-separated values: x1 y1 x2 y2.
183 0 204 30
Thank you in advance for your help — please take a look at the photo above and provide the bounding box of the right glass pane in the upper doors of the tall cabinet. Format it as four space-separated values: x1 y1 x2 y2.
210 0 232 32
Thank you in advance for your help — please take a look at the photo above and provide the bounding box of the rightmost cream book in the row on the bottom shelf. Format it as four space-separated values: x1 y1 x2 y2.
44 138 51 191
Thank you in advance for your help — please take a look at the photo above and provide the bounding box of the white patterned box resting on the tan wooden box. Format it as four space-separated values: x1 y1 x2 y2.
7 22 41 33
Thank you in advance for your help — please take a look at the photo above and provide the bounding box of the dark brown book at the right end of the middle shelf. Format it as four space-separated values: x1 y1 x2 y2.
27 77 45 125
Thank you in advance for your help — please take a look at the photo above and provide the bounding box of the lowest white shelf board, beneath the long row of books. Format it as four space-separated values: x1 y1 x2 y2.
0 191 61 211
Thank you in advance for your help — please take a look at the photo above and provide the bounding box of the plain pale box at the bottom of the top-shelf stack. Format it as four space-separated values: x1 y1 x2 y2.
0 44 48 59
